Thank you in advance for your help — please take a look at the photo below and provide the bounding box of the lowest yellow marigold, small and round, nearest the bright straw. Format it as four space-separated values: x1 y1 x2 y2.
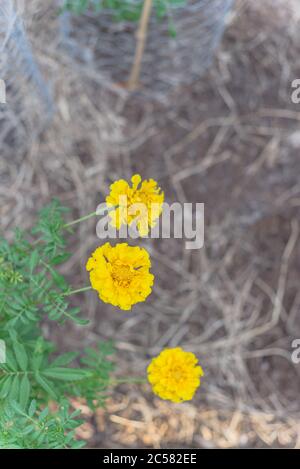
147 347 204 402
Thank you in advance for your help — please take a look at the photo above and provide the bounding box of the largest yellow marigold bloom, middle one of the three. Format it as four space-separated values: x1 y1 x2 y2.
86 243 154 310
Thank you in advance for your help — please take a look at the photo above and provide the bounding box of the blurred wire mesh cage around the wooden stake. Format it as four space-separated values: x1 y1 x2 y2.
61 0 233 97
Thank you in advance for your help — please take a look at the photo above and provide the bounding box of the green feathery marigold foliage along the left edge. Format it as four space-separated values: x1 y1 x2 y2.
0 200 114 448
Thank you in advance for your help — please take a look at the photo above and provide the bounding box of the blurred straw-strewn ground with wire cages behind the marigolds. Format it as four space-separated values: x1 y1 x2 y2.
0 0 300 448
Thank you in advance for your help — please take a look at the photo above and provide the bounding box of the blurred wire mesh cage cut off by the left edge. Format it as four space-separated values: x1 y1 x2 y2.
0 0 53 157
